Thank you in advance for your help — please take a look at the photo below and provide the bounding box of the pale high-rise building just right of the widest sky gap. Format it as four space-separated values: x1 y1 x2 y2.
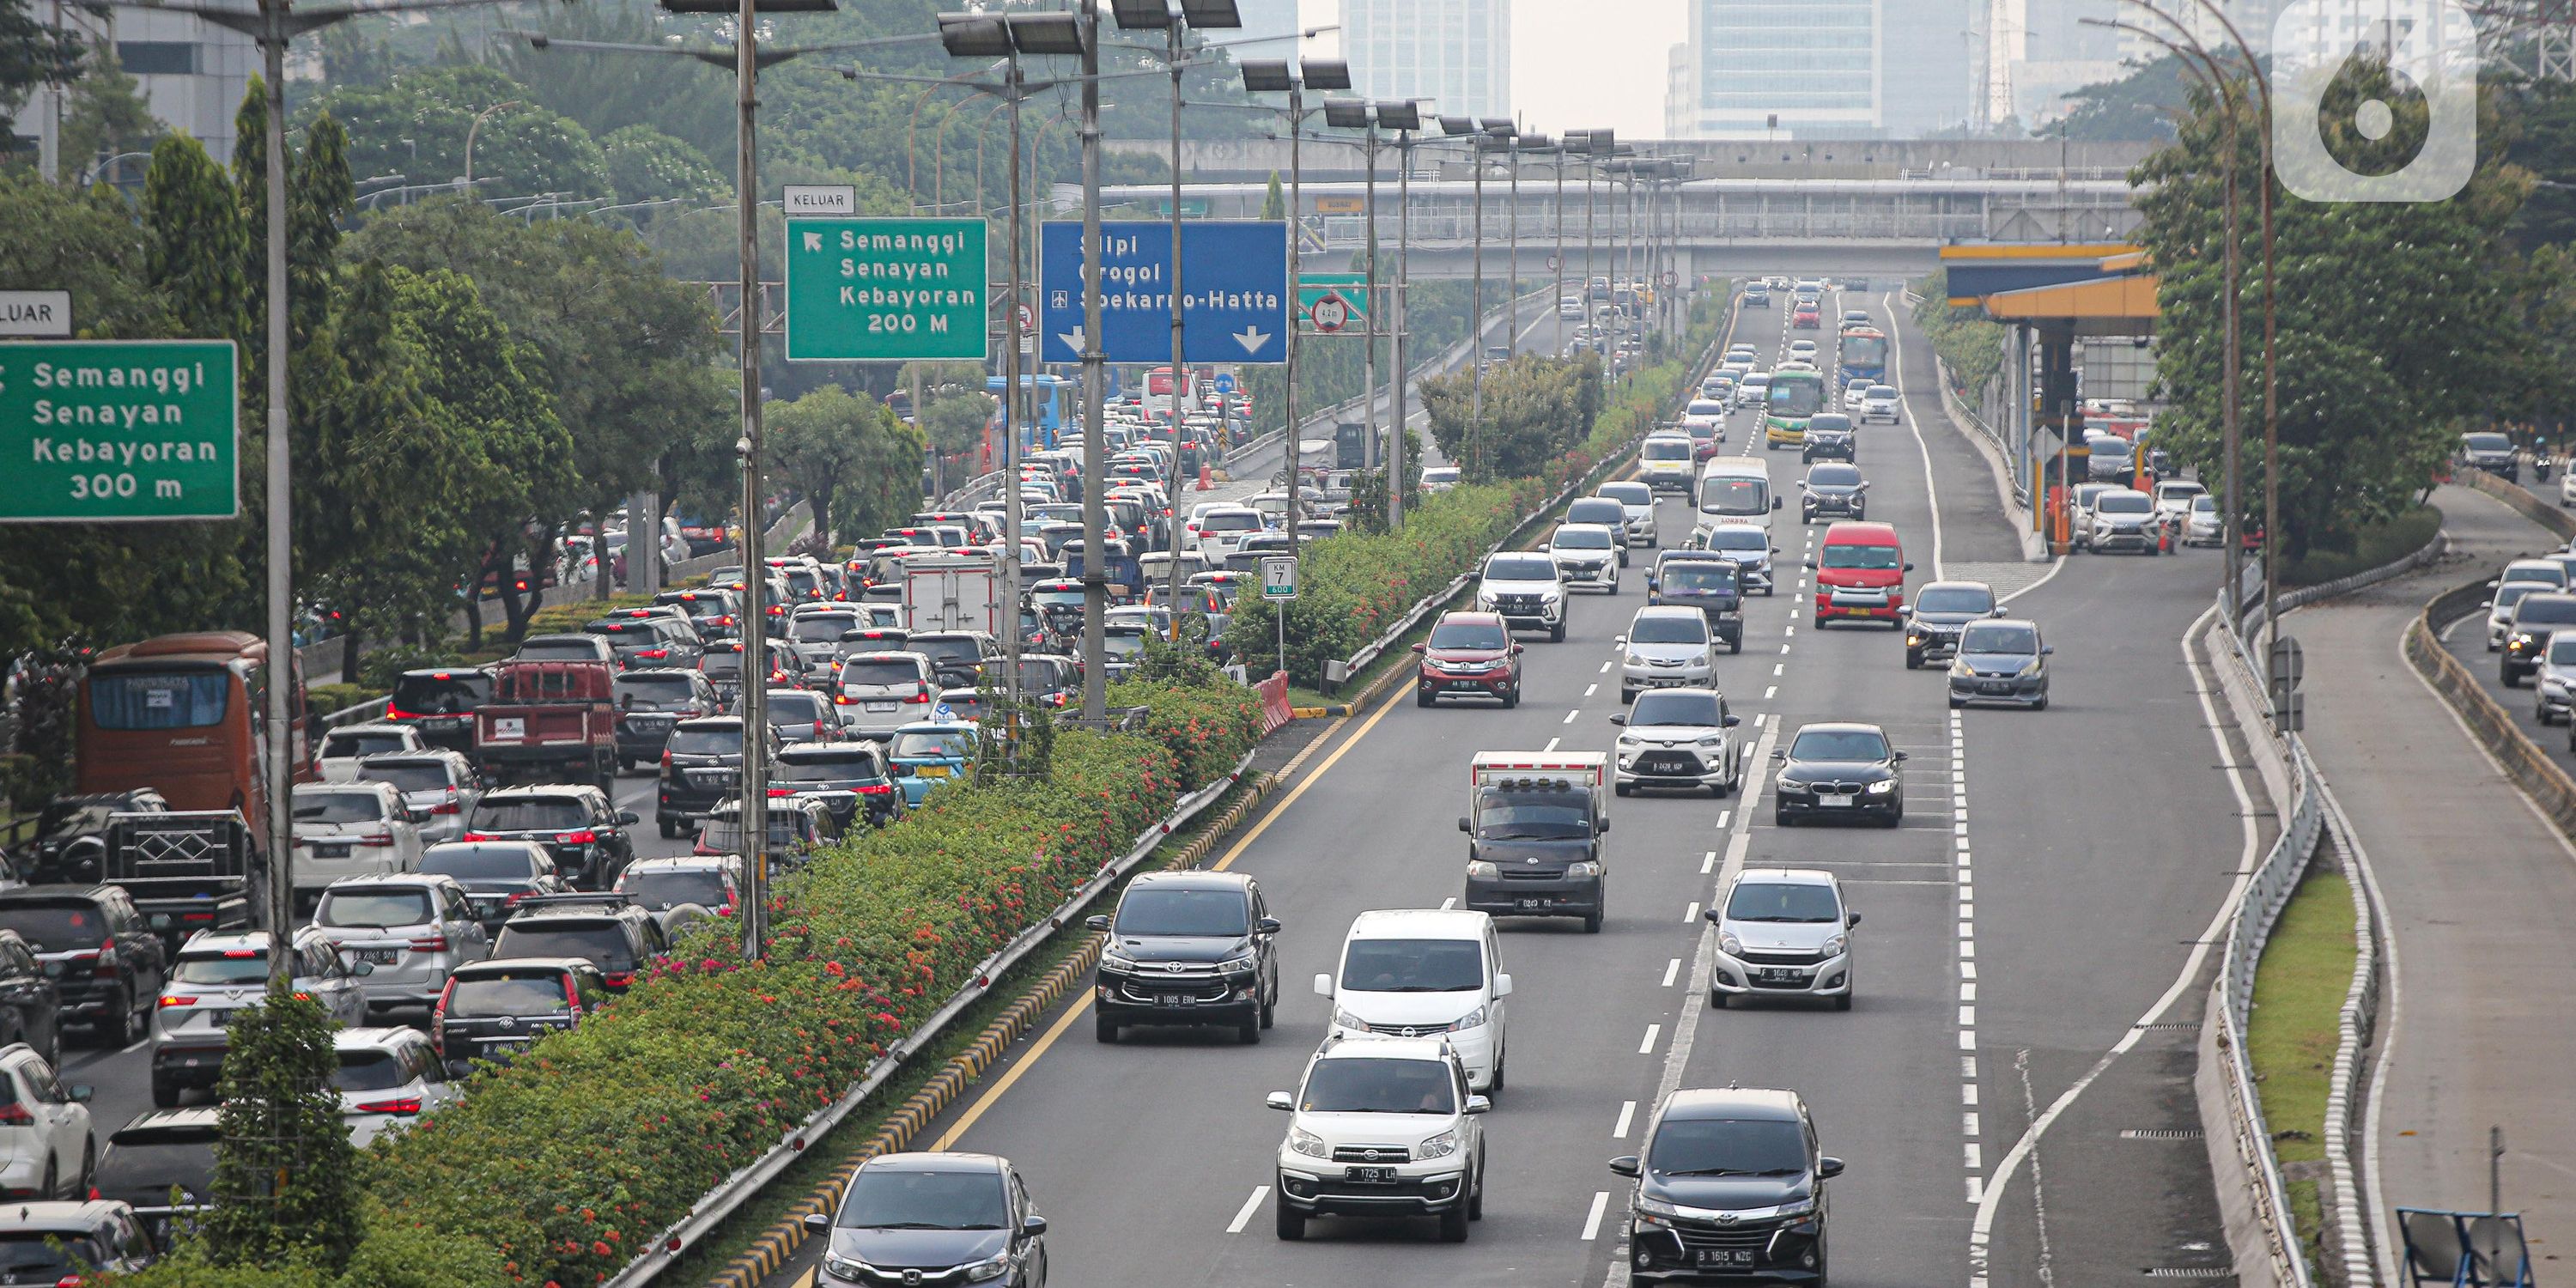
1687 0 1875 139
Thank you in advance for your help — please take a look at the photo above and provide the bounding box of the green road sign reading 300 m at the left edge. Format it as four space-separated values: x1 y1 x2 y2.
0 340 242 523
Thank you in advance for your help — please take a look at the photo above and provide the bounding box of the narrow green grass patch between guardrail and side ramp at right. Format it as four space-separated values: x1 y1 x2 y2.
2246 868 2357 1267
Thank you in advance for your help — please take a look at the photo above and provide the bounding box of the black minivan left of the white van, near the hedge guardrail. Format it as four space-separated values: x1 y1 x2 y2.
1084 871 1280 1043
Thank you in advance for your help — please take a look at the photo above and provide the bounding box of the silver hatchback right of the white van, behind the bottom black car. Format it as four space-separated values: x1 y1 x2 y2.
1705 868 1860 1010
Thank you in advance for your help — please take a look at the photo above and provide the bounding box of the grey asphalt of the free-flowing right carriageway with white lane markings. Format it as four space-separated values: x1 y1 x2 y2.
752 284 2249 1288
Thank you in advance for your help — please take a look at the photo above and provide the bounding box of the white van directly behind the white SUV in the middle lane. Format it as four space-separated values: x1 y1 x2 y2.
1314 909 1512 1092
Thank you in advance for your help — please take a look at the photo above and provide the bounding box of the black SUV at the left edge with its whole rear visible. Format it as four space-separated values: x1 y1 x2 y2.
0 886 170 1046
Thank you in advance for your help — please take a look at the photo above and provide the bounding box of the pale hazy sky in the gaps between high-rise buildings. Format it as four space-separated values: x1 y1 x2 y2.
1273 0 1690 139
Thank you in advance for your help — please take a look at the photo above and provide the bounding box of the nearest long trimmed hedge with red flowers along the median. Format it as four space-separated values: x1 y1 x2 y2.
121 683 1260 1288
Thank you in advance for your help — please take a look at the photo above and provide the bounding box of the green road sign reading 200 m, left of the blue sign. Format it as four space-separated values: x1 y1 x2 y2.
786 219 992 363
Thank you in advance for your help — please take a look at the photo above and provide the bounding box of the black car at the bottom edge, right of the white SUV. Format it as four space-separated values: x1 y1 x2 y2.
1610 1087 1842 1283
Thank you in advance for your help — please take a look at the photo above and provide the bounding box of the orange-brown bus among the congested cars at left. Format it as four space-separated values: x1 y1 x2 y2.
75 631 312 832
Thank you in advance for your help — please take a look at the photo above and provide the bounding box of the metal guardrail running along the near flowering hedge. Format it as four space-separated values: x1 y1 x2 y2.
605 752 1252 1288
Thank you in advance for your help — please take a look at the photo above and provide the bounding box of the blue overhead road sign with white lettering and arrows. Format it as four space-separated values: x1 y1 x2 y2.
1038 219 1288 366
